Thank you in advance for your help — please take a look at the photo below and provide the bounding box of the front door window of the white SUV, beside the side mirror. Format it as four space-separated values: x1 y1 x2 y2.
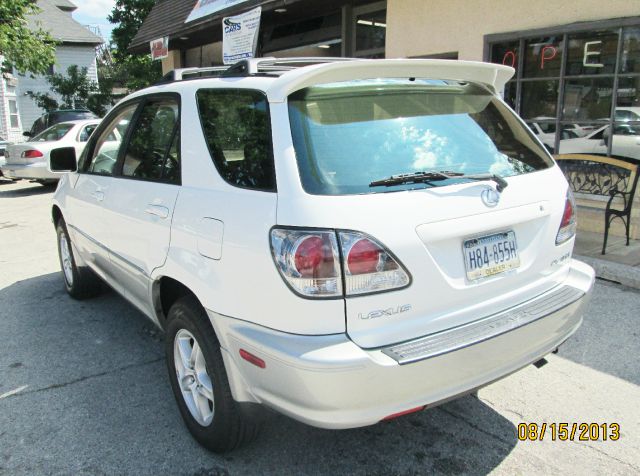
87 104 138 175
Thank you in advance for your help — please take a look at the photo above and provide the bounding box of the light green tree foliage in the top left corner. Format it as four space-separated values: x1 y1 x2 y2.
0 0 55 74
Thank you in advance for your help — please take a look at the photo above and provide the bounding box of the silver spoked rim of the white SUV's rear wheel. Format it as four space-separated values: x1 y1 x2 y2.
173 329 214 426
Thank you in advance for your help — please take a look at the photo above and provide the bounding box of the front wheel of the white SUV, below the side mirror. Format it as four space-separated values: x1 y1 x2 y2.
56 218 102 300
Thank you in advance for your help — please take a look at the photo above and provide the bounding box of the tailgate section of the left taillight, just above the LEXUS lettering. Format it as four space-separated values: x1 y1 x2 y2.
338 231 409 296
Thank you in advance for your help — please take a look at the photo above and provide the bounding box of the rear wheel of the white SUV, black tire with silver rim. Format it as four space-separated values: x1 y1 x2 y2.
165 296 262 453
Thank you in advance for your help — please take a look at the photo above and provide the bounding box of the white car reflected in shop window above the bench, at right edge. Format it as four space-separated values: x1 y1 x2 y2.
559 124 640 160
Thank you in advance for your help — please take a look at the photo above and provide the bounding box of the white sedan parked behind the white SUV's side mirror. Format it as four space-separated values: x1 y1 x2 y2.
0 119 100 184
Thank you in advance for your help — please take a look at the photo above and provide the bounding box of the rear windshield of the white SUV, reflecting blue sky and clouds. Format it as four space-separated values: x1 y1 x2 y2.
289 79 553 195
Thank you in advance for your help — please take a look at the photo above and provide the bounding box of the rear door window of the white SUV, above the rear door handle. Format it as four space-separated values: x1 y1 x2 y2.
122 98 180 183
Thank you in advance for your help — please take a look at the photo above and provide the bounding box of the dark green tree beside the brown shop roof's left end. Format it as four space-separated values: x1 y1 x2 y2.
107 0 162 90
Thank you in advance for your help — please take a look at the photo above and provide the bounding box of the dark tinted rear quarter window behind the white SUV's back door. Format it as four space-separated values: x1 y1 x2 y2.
197 89 276 191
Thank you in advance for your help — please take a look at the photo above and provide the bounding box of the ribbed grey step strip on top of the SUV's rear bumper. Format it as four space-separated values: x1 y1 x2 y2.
380 286 585 365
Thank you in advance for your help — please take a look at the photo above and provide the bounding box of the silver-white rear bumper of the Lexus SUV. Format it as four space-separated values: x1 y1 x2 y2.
209 260 594 429
